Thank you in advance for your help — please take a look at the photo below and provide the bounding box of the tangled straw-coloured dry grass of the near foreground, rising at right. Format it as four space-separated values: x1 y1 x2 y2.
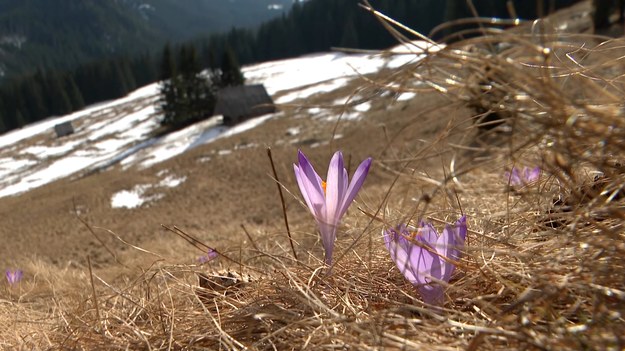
0 5 625 350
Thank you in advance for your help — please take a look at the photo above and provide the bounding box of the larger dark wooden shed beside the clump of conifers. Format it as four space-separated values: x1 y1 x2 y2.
213 84 276 126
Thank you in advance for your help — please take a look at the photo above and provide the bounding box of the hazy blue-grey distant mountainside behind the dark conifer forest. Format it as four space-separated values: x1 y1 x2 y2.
0 0 292 80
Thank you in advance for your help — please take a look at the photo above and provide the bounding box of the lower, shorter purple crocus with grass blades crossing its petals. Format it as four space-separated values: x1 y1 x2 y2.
384 216 467 305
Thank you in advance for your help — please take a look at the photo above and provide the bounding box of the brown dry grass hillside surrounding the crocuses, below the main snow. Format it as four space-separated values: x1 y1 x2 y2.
0 2 625 350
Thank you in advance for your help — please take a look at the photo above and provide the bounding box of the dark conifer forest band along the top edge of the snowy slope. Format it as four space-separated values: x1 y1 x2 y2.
0 0 575 132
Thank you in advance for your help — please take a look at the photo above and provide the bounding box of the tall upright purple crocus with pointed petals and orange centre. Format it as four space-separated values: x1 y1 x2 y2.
293 150 372 266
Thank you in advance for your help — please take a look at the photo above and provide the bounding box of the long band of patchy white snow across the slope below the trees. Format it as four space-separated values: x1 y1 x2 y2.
0 43 438 197
